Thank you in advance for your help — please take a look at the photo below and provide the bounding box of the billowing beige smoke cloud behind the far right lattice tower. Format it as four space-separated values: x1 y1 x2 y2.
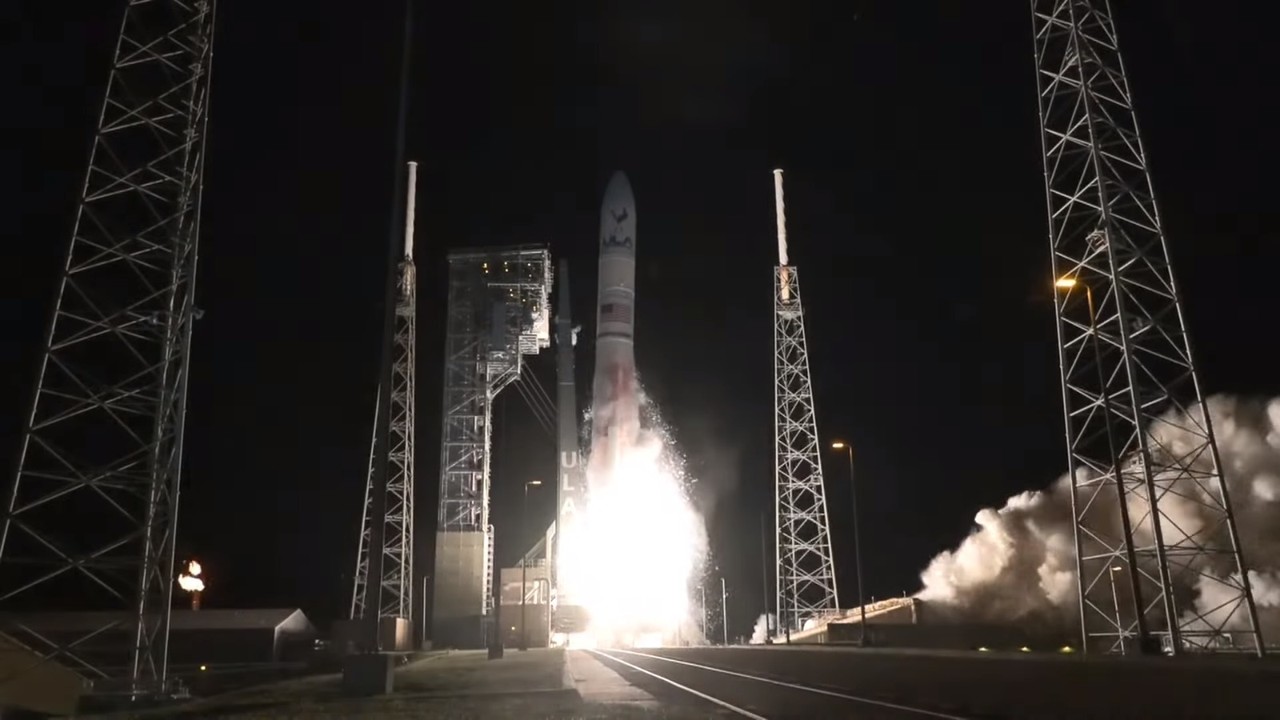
916 396 1280 638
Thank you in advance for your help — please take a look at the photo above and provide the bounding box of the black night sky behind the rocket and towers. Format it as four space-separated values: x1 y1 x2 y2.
0 0 1280 633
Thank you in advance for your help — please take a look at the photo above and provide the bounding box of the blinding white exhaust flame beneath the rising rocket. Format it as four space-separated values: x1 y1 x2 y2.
559 397 707 647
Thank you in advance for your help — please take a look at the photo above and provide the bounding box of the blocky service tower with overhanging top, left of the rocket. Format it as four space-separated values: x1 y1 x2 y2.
431 246 553 648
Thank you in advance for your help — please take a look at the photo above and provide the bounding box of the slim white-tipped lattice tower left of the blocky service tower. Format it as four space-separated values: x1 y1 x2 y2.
351 163 425 621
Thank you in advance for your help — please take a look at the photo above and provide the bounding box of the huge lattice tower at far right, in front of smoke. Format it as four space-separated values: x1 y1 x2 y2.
1032 0 1263 653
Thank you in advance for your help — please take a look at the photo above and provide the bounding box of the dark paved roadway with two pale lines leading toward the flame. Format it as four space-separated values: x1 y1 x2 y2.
575 646 1280 720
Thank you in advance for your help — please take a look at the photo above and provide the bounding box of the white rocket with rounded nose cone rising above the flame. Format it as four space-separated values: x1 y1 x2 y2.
591 170 640 466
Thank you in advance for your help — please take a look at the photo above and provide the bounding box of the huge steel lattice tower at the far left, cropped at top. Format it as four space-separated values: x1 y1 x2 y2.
0 0 214 697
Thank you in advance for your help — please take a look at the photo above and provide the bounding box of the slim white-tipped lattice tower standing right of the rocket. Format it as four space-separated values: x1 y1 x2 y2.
773 170 840 630
